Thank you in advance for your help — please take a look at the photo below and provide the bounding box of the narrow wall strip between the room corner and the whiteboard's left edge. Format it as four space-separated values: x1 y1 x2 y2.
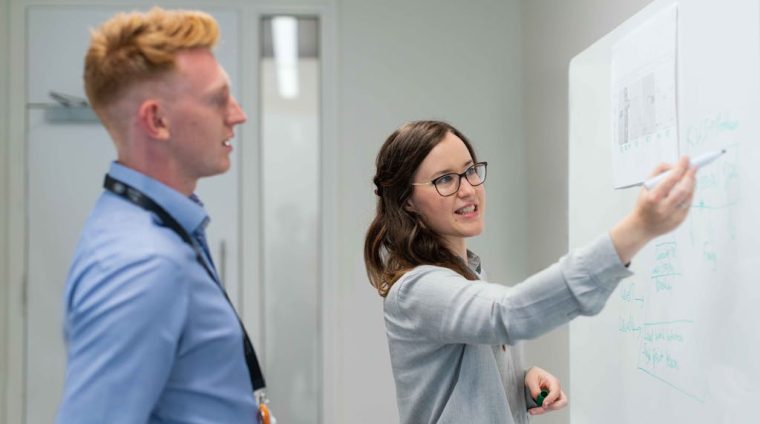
522 0 651 424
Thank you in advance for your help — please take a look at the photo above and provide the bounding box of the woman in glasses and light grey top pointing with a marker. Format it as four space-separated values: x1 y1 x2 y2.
364 121 696 424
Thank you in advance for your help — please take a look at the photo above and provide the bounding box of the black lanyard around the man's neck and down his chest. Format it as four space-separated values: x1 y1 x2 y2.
103 174 266 390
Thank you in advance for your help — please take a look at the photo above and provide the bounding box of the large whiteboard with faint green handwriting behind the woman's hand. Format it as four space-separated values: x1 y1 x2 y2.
568 0 760 424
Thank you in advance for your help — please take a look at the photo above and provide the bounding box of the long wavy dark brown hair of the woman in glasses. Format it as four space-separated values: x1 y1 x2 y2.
364 121 477 297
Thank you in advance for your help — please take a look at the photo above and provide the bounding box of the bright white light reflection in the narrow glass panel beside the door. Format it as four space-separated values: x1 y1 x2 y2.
272 16 298 99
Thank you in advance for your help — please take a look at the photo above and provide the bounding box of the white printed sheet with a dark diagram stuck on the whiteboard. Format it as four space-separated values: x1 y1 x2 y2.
611 6 678 188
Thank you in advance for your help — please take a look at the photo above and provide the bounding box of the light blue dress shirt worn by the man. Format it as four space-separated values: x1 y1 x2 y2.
57 163 255 424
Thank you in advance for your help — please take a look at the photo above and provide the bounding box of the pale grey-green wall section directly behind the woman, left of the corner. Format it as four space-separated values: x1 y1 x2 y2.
336 0 526 424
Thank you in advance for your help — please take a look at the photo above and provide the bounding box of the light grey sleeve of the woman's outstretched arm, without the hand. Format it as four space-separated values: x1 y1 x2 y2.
384 234 631 345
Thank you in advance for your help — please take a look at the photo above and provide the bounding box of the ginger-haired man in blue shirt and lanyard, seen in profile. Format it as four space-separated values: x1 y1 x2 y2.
57 8 263 424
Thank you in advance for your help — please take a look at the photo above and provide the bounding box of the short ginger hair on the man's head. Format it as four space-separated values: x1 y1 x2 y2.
84 7 219 115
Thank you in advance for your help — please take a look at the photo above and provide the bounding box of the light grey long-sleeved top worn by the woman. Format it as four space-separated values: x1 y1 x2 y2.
384 234 631 424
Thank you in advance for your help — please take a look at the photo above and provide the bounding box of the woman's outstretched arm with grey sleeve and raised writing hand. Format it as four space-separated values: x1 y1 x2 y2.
385 158 695 344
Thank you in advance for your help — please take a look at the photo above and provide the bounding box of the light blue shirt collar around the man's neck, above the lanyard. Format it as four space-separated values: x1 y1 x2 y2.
108 162 209 234
